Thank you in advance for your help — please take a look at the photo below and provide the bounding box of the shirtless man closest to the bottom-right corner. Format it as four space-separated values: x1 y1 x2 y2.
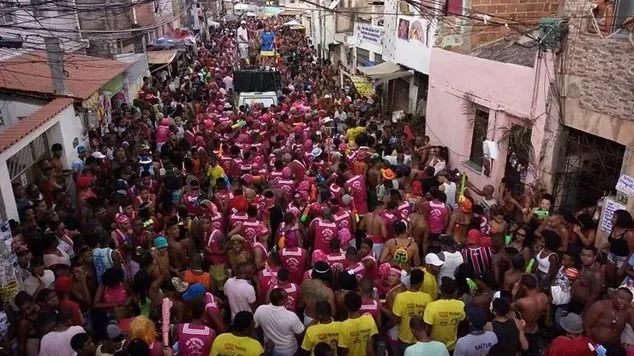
583 287 634 345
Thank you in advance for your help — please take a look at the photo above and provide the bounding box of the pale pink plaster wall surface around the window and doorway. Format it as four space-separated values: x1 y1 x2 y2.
426 48 553 189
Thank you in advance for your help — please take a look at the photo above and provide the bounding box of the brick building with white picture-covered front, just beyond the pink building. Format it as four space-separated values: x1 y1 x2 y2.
360 0 559 116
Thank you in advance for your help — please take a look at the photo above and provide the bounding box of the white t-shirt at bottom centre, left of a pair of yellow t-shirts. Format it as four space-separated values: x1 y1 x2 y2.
253 304 304 355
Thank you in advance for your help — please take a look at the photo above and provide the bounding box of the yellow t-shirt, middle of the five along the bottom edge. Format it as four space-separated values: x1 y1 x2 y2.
339 314 379 356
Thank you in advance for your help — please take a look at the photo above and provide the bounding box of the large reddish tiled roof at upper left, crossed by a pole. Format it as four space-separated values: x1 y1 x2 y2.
0 51 130 100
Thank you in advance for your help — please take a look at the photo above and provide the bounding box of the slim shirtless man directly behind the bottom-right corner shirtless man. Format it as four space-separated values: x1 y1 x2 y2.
568 246 605 316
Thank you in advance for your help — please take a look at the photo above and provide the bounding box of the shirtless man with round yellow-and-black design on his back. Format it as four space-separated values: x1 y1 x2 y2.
379 221 421 268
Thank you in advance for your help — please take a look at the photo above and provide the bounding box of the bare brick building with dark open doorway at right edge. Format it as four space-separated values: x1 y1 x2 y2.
544 0 634 241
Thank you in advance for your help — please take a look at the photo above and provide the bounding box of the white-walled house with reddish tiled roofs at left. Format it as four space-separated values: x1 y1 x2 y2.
0 51 131 220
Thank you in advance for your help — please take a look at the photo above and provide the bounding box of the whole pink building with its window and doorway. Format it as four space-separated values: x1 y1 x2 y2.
426 44 556 192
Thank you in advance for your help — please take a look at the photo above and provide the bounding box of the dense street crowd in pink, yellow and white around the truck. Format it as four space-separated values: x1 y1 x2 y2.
0 12 634 356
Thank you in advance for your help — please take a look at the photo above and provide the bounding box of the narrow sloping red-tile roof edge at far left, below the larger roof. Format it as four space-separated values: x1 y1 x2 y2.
0 98 73 153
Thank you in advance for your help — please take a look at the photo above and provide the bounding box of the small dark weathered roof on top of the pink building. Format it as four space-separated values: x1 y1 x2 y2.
469 36 539 68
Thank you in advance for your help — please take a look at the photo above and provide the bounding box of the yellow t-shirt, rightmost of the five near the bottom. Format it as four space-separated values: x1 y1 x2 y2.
423 299 467 350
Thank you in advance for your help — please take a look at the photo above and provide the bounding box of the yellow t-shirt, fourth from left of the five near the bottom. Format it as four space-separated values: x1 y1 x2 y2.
392 290 431 344
